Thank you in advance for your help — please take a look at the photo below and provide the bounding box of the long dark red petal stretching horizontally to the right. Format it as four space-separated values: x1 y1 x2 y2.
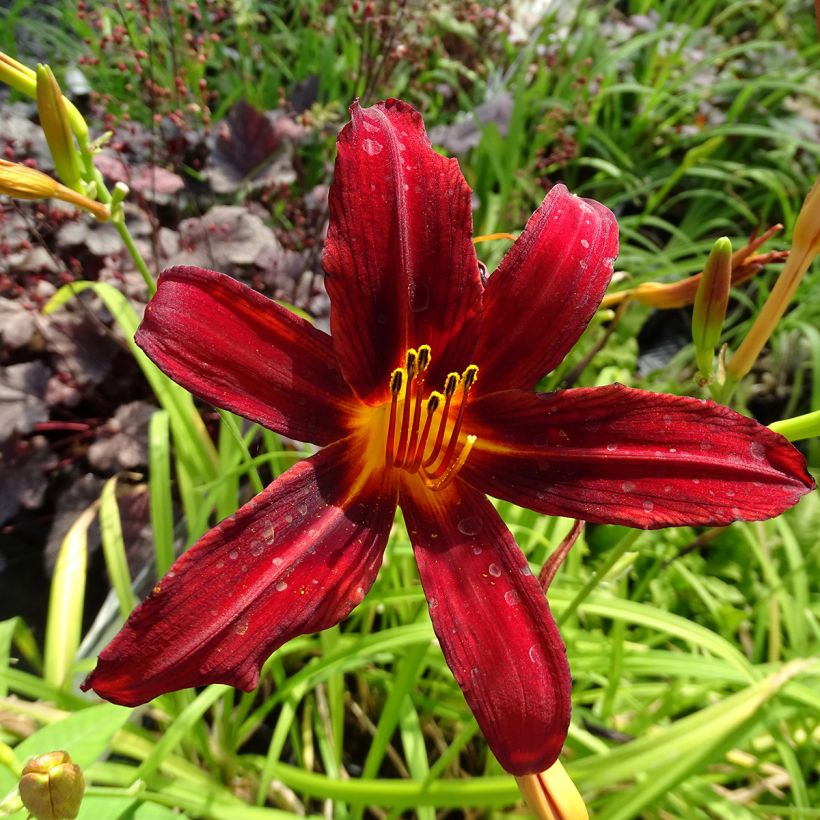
461 385 814 528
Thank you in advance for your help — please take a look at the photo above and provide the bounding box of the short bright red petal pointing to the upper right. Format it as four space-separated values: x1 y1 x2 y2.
475 185 618 393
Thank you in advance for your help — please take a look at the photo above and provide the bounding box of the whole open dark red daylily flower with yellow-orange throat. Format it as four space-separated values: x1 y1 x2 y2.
84 100 813 775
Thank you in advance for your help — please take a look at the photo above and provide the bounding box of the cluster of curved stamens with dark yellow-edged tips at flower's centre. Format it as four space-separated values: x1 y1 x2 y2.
385 345 478 490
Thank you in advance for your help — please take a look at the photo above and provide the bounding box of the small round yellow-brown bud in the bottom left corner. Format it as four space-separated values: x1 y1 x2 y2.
20 752 85 820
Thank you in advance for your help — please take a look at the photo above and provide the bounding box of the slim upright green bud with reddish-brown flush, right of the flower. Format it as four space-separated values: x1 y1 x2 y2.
692 236 732 381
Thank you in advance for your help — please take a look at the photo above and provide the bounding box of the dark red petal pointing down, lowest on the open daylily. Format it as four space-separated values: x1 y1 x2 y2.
400 481 571 775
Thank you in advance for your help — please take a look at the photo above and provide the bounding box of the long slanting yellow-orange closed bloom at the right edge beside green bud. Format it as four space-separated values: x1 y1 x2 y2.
726 177 820 389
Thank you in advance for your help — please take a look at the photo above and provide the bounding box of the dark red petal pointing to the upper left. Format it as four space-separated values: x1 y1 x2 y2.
136 267 355 444
